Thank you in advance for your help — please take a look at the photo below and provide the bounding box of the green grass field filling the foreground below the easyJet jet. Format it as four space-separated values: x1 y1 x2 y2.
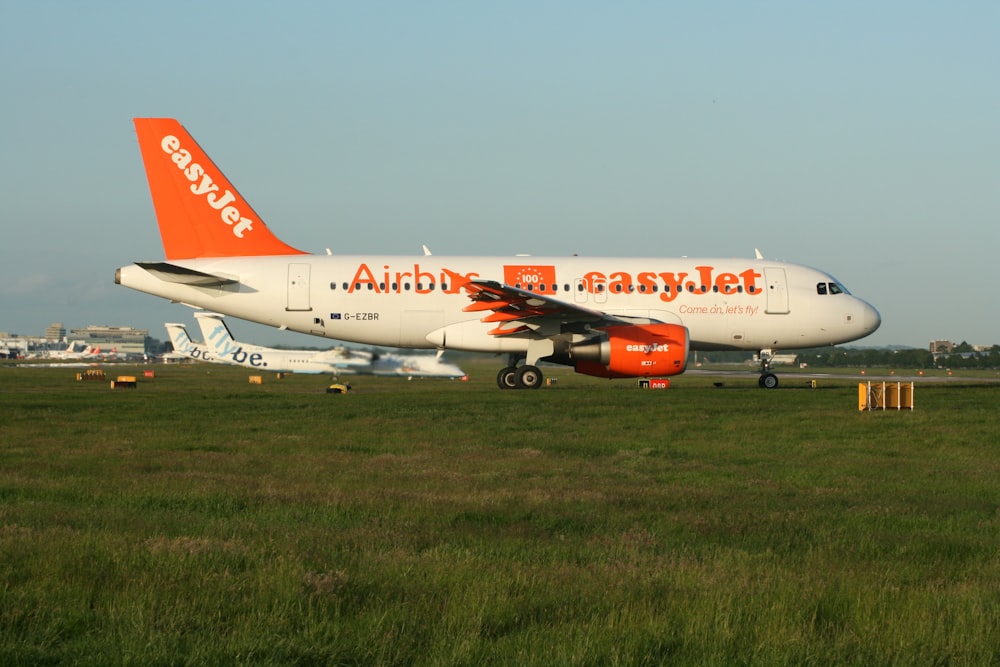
0 362 1000 665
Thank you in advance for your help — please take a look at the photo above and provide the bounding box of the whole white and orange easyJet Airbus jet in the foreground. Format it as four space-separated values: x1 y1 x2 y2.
115 118 881 389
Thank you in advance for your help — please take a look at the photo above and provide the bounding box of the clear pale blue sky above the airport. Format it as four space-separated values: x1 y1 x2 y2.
0 0 1000 347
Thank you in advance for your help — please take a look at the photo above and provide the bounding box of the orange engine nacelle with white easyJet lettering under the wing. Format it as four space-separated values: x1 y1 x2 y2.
571 324 688 378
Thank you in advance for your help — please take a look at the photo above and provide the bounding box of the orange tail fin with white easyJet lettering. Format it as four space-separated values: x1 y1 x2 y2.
135 118 305 259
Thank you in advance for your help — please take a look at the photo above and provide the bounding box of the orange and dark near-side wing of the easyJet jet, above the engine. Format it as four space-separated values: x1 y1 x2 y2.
462 280 629 336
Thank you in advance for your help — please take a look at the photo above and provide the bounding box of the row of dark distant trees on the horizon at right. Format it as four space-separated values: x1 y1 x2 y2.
698 342 1000 369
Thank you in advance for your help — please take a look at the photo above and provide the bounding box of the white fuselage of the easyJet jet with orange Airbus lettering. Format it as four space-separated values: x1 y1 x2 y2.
116 255 880 353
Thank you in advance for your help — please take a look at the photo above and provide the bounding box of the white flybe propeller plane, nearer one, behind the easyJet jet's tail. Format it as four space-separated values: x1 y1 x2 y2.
194 313 465 378
